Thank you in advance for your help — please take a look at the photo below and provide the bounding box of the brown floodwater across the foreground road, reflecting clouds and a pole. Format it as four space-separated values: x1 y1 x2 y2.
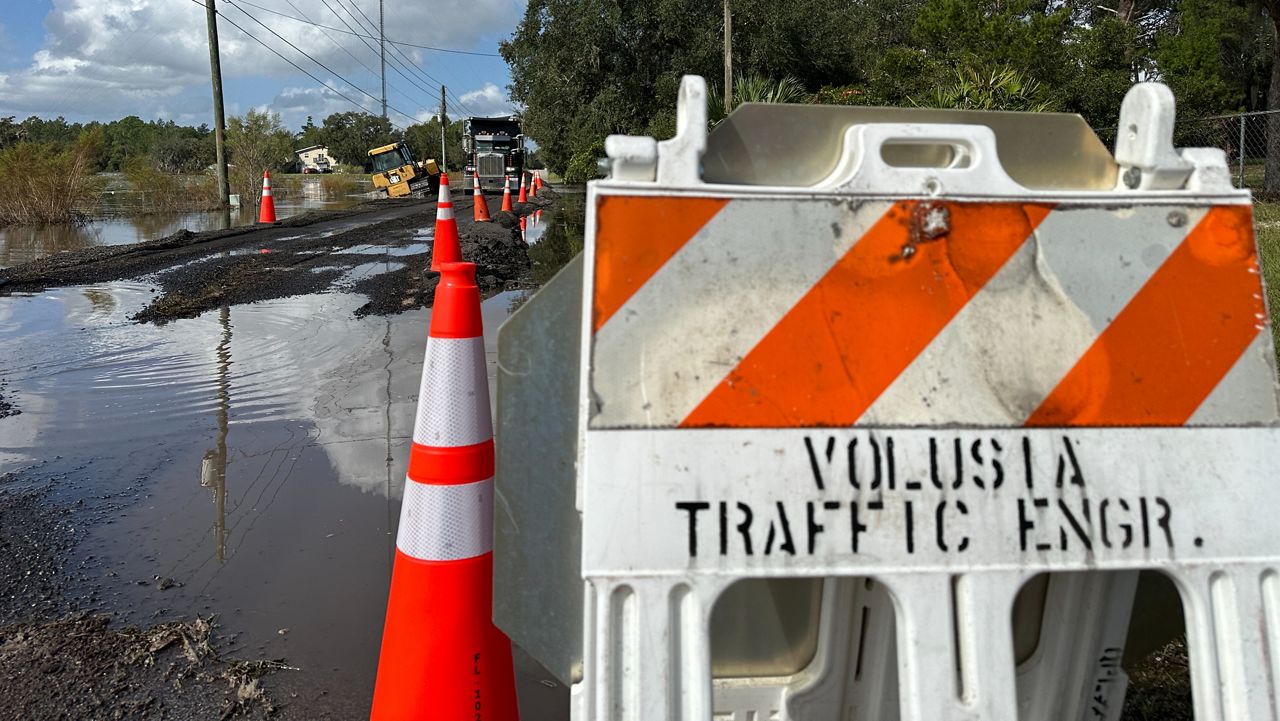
0 194 581 720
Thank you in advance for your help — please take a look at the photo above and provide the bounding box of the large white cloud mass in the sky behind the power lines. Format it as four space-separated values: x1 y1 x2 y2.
0 0 524 120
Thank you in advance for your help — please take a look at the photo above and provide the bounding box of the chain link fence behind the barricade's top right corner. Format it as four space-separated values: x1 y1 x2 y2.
1094 110 1280 190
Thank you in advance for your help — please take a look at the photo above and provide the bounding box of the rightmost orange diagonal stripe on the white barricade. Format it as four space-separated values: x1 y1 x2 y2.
1027 205 1266 425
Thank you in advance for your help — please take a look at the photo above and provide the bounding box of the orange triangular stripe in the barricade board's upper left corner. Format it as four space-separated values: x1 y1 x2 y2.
591 196 728 332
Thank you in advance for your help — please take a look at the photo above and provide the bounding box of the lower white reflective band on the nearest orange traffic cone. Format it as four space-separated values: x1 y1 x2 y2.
396 478 493 561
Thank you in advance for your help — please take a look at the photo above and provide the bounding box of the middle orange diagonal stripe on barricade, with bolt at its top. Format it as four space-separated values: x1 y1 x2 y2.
681 201 1050 428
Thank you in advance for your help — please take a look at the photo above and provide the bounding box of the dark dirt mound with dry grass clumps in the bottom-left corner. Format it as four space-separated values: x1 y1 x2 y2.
0 616 283 721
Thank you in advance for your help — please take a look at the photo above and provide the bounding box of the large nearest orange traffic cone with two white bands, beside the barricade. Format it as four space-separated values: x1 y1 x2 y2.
370 263 520 721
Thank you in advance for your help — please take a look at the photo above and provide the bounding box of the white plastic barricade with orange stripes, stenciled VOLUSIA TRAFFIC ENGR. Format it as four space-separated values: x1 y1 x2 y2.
497 77 1280 721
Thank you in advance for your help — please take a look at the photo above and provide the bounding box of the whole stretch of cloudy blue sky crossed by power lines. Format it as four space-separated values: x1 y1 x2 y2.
0 0 525 129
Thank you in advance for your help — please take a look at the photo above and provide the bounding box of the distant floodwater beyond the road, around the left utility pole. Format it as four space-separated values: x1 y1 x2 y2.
0 177 365 268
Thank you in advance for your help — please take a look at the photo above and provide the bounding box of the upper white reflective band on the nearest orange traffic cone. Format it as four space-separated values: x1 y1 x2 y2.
413 337 493 448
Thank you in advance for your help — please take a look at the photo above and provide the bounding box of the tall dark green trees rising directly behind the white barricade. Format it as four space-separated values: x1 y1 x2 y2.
500 0 1280 184
